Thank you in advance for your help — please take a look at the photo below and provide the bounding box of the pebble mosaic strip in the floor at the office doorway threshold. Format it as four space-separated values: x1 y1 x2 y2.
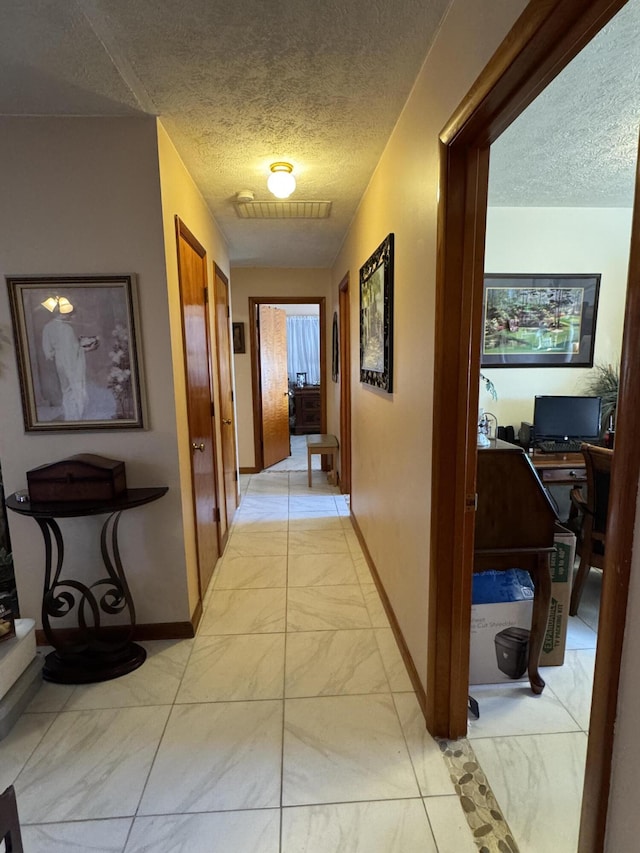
436 738 520 853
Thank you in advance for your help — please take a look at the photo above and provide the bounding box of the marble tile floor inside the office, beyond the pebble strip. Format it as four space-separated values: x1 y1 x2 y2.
468 569 602 853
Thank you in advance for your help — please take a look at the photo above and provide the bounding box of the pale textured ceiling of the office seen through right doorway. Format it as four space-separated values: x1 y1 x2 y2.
489 0 640 207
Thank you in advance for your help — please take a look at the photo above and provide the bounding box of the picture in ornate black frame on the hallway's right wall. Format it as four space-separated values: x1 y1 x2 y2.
360 234 393 394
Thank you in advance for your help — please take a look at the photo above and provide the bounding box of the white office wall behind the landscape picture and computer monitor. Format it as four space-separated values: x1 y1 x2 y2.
480 207 631 432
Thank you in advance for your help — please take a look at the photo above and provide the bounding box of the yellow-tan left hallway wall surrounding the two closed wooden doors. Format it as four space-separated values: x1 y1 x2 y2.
158 122 229 612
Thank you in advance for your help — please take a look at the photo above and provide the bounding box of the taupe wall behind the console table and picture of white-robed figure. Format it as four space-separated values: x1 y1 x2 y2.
0 118 190 622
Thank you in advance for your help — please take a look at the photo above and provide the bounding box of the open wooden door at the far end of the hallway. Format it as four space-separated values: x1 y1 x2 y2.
258 305 291 468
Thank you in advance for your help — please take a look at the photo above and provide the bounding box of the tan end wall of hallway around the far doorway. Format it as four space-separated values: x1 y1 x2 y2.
231 267 333 468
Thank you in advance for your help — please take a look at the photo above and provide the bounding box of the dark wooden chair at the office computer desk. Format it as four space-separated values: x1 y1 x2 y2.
569 444 613 616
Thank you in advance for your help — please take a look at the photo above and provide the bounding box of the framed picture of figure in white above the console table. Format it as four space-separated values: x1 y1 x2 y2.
7 275 144 432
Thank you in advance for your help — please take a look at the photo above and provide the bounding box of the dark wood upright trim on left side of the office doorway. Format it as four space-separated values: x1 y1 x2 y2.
426 145 489 738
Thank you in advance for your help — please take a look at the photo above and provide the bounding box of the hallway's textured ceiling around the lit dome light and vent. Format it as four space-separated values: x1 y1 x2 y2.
0 0 449 267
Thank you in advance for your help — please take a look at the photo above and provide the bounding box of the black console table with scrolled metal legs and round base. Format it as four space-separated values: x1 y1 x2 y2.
6 486 168 684
